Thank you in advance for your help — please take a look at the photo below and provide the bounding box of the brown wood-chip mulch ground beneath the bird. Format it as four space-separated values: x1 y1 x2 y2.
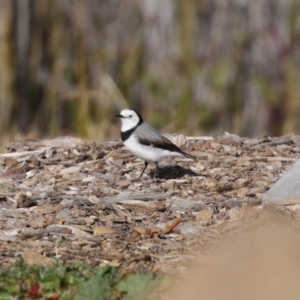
0 134 300 272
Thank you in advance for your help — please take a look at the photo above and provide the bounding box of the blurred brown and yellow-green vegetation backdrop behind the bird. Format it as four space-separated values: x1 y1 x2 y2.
0 0 300 146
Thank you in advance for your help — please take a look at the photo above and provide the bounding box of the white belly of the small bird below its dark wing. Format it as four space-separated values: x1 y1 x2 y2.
124 137 181 162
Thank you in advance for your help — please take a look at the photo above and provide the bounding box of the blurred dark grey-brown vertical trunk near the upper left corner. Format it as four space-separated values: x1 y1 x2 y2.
13 0 30 134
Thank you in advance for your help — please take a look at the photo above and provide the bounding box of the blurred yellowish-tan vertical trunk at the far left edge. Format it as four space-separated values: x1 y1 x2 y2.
0 0 14 134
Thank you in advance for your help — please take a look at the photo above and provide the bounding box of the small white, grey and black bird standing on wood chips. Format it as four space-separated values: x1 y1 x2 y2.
116 109 197 181
